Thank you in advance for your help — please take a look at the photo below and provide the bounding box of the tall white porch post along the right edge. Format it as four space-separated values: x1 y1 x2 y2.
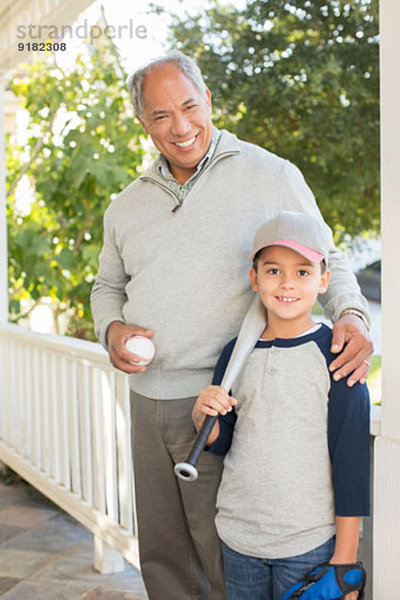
374 0 400 600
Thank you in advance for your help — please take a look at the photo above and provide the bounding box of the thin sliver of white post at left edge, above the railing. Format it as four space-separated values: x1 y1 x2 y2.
0 81 8 323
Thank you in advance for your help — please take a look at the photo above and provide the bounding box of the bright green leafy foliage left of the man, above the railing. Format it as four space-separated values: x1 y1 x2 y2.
7 43 143 339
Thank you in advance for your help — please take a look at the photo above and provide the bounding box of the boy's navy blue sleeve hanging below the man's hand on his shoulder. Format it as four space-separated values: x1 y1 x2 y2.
328 379 370 517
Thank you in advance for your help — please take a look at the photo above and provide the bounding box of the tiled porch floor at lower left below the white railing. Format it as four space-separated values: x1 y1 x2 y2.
0 482 147 600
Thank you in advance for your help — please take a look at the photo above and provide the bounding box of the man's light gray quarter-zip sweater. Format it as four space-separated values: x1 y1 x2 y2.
92 131 368 399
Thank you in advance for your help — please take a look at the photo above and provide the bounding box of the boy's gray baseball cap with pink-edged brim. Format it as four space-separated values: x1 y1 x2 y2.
249 210 332 264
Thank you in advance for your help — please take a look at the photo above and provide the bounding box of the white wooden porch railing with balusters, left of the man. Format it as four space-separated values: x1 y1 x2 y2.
0 324 139 572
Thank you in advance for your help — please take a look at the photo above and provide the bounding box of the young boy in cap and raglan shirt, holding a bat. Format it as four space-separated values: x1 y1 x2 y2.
193 212 369 600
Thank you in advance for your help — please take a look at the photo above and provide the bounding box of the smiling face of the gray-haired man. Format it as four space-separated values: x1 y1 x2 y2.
139 63 212 184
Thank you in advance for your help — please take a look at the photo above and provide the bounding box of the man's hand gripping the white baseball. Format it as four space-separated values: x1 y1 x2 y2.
107 321 154 373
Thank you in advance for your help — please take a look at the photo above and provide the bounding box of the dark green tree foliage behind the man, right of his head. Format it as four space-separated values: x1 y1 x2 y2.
164 0 380 240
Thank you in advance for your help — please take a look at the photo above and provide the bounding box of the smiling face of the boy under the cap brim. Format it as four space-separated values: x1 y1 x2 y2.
249 246 329 326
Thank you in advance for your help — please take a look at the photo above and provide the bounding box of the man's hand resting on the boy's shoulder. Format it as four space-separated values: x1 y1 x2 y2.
329 314 374 387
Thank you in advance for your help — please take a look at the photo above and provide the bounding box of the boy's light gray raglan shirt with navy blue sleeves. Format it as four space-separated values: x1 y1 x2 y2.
209 325 370 558
